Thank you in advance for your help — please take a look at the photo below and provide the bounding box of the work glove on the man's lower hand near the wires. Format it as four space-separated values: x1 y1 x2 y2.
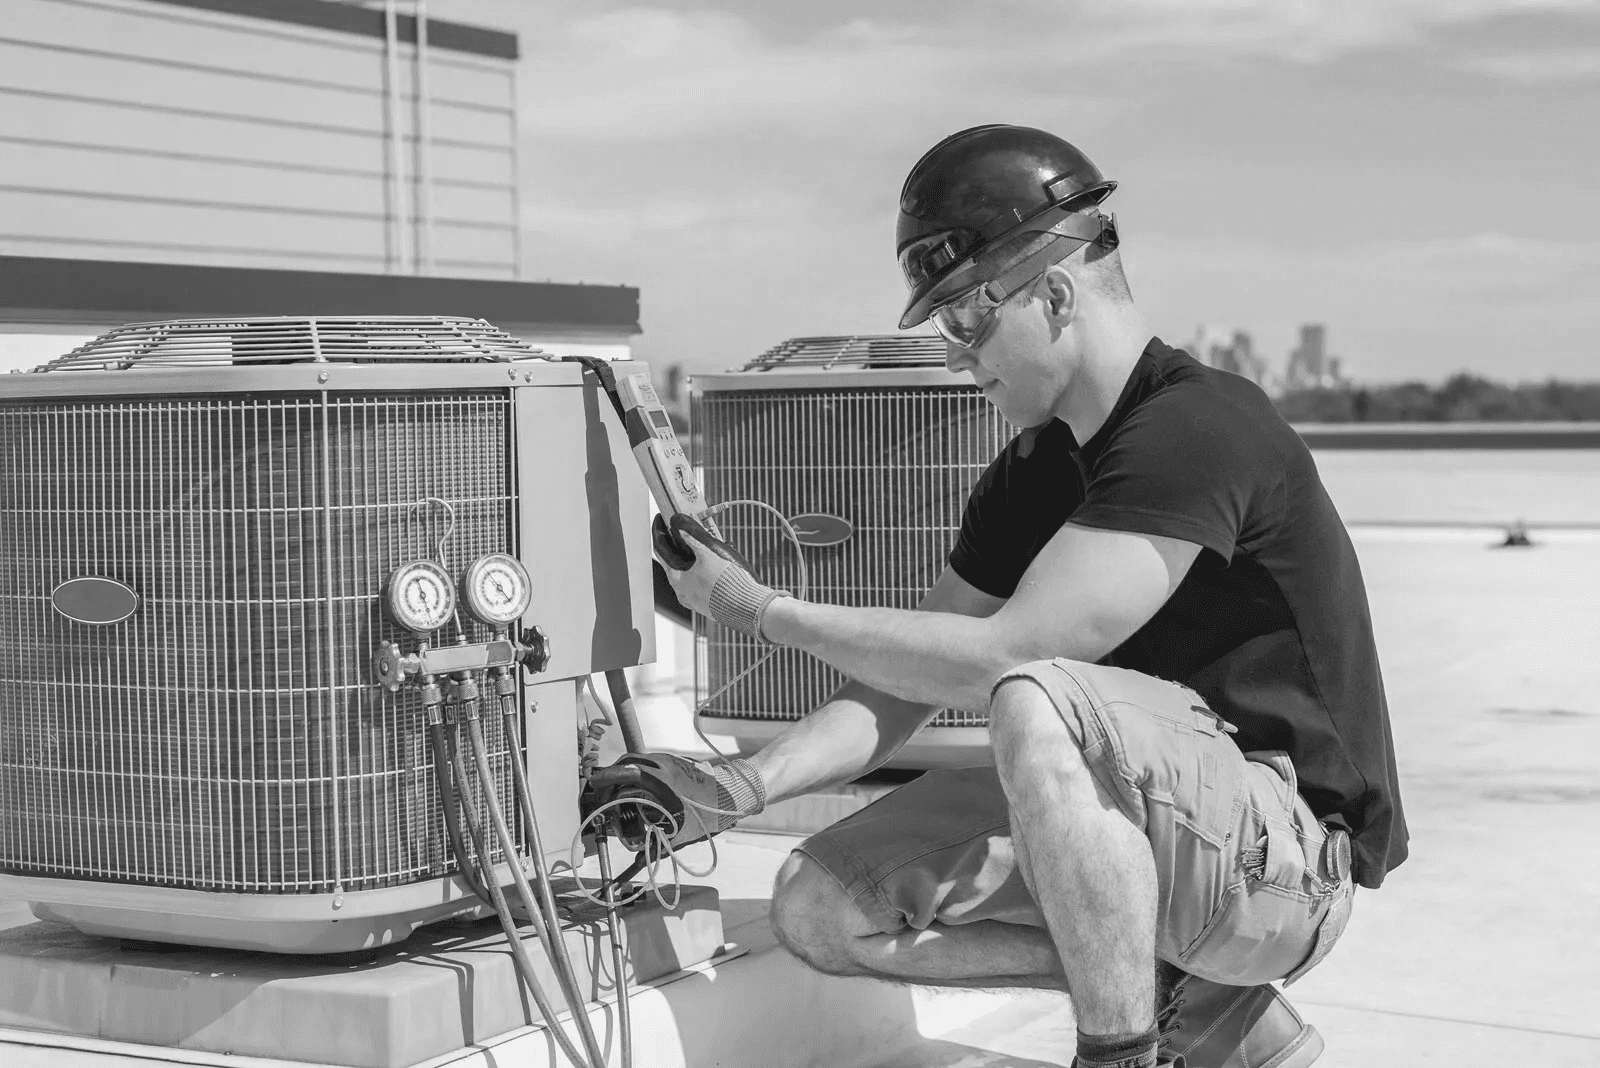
579 753 766 852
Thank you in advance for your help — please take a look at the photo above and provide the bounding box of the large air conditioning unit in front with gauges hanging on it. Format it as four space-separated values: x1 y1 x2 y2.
0 318 653 953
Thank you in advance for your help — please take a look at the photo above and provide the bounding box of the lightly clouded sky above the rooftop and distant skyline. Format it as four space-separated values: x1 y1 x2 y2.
430 0 1600 382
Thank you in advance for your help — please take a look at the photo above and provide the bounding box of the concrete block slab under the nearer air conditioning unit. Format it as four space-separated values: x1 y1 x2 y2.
0 887 723 1068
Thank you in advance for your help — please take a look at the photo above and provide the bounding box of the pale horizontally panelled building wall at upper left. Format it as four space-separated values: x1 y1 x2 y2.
0 0 520 278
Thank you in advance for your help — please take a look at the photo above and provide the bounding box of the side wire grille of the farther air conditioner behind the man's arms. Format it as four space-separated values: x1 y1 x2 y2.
691 383 1016 726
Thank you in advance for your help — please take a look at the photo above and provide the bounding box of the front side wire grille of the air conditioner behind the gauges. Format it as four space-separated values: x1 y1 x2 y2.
0 392 515 894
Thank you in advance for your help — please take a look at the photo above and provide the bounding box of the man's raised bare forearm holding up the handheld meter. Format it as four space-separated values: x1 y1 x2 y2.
762 598 1024 711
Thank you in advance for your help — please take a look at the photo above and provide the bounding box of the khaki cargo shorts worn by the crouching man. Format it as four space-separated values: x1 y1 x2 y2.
800 660 1355 986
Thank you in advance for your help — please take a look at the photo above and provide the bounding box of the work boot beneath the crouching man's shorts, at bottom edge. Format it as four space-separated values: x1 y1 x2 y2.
1157 962 1323 1068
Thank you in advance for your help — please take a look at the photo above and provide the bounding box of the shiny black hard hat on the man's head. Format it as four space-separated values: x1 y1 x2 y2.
894 125 1117 329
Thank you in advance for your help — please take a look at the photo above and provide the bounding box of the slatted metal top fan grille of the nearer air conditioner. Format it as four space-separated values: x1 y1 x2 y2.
37 315 544 371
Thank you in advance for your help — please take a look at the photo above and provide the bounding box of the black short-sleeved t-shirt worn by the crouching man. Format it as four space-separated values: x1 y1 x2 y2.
950 339 1406 887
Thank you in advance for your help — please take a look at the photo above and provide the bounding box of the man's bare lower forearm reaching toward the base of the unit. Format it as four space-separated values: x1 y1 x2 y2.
750 683 938 804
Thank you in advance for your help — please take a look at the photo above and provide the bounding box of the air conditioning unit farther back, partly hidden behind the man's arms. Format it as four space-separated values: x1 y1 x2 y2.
690 336 1016 767
